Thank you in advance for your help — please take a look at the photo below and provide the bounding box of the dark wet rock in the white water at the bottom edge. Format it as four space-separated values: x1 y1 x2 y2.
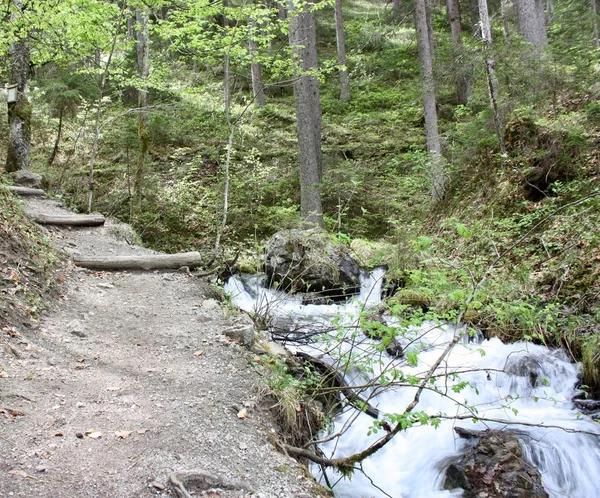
444 429 548 498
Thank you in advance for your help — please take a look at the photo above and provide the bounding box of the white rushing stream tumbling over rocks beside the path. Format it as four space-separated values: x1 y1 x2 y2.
225 270 600 498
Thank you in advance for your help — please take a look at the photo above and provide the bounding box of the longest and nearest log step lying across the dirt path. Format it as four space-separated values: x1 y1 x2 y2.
73 251 202 270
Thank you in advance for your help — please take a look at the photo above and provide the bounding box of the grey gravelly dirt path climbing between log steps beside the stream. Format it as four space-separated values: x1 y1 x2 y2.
0 200 324 498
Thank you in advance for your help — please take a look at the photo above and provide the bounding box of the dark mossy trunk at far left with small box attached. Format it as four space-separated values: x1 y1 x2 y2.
6 1 31 172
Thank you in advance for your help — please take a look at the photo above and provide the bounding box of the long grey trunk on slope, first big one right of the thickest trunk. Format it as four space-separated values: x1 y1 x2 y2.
414 0 446 201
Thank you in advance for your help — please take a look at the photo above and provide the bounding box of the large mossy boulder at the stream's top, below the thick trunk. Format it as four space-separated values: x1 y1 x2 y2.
265 229 360 300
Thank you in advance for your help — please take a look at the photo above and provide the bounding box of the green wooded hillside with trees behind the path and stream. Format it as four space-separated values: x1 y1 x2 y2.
0 0 600 496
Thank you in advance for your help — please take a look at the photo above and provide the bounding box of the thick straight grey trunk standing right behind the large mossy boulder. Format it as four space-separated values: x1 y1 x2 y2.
289 0 323 226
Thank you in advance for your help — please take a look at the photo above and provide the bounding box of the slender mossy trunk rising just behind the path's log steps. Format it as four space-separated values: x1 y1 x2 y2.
133 9 150 213
